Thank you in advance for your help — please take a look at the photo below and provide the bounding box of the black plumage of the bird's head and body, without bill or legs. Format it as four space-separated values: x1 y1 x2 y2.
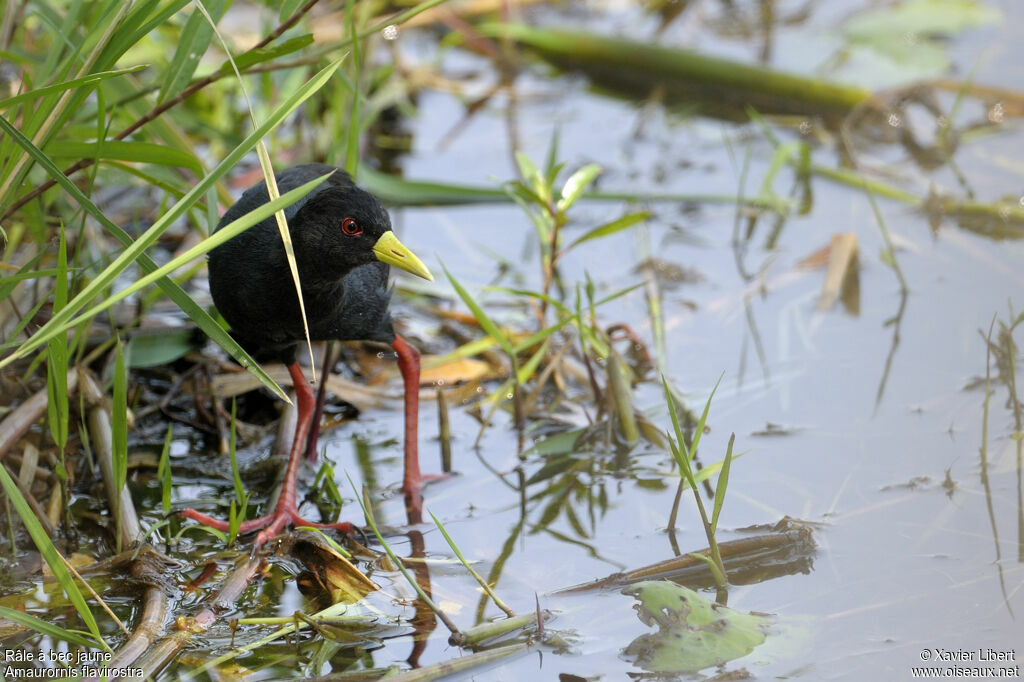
210 164 394 365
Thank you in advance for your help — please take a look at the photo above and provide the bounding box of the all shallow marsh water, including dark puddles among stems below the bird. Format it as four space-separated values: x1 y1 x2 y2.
46 0 1024 680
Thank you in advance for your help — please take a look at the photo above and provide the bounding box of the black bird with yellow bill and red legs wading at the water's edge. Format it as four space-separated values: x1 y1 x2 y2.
182 164 433 545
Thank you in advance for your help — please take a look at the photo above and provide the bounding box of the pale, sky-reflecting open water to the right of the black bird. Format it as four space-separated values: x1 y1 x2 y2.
331 2 1024 680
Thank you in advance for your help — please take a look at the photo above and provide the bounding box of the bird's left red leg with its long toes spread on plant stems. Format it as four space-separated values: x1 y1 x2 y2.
181 363 353 547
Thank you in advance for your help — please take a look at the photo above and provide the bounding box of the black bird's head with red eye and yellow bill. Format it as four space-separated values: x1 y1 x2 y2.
289 176 434 281
